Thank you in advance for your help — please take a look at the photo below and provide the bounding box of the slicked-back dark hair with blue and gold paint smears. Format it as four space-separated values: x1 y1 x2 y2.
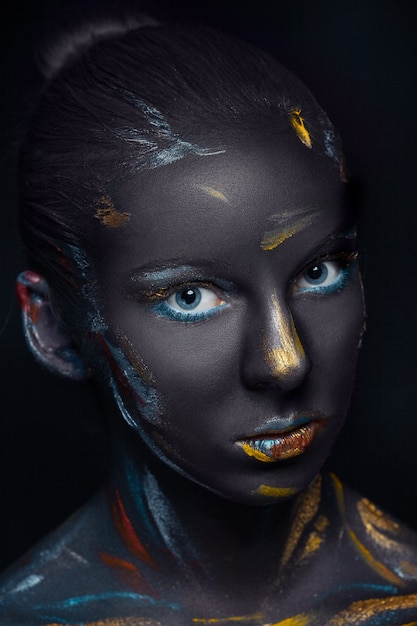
19 14 340 334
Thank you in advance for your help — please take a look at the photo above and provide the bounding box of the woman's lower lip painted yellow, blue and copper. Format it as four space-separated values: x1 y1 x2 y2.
236 421 323 463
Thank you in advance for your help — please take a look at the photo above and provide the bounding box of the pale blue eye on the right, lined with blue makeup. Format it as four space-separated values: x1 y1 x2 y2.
294 261 354 295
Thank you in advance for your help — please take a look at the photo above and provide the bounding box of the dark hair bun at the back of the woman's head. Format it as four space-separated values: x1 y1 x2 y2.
37 11 159 80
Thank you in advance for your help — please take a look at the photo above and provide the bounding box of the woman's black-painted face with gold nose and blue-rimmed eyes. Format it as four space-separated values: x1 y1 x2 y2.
93 130 363 504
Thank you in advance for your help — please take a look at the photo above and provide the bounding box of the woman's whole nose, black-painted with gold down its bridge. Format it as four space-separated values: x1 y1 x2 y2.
243 293 310 390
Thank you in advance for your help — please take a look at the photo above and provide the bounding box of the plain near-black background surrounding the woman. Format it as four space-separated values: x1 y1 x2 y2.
0 0 417 567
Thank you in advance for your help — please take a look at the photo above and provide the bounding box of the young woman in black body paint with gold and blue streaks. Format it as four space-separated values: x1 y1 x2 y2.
0 14 417 626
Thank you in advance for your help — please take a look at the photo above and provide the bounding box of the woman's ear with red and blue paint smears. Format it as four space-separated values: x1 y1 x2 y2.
16 271 91 380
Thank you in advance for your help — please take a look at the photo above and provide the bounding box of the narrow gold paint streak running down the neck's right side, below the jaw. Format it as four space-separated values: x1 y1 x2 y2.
280 474 322 572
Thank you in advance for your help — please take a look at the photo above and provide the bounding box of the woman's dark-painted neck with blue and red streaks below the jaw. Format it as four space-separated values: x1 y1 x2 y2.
102 416 308 589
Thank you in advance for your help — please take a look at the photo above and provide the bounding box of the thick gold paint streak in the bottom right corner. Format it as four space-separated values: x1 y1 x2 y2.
325 594 417 626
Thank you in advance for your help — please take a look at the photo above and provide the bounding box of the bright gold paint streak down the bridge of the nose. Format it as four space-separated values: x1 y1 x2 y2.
264 294 305 377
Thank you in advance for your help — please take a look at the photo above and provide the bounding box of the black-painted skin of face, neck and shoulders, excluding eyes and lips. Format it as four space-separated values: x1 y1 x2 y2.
0 125 417 626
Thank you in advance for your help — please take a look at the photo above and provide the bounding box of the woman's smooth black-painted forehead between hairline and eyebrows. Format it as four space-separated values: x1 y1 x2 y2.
96 132 344 263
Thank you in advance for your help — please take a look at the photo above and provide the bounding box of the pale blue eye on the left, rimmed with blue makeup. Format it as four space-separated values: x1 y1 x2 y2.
153 286 227 322
